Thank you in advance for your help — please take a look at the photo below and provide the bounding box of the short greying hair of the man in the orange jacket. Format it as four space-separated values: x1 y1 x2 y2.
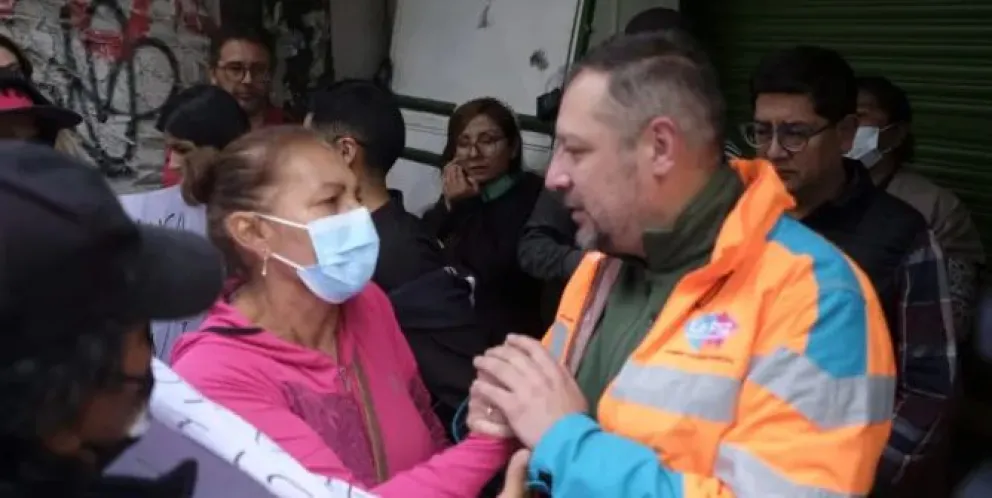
569 30 726 147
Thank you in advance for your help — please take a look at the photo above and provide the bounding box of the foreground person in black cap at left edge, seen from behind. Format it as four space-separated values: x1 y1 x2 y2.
0 141 223 498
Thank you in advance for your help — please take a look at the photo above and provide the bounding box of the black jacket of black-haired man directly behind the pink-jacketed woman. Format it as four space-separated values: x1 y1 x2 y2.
372 191 488 431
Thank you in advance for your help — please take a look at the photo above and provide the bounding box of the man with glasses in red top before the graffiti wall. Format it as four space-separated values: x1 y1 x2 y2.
210 25 285 128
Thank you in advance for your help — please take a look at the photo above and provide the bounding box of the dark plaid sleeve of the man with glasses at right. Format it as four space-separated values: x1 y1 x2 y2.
876 231 957 490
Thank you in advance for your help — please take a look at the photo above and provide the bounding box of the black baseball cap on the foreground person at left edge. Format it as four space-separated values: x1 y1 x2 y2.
0 141 224 333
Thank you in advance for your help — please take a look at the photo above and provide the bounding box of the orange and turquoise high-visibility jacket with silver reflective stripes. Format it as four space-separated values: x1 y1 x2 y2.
530 161 895 498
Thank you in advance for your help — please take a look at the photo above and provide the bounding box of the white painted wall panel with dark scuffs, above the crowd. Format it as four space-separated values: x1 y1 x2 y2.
392 0 581 114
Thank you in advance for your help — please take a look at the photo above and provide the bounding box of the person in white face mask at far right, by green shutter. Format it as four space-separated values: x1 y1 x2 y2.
847 76 985 342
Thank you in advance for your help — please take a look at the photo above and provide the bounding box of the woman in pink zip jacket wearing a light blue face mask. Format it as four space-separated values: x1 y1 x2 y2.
172 127 513 498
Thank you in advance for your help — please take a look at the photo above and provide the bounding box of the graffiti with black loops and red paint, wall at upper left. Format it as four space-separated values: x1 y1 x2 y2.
0 0 212 185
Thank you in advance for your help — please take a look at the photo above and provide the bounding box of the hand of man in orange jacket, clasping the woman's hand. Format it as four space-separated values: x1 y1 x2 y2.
471 335 588 448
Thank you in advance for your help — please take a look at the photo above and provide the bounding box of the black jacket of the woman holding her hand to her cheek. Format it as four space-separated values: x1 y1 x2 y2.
424 173 544 344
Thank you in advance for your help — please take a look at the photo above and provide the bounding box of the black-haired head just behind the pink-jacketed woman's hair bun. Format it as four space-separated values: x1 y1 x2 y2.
155 85 251 190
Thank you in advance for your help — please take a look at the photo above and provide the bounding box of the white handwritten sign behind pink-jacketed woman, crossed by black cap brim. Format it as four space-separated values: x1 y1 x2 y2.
118 186 213 361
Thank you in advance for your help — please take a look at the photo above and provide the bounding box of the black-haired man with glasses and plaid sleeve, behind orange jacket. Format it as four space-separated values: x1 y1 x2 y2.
742 46 956 497
